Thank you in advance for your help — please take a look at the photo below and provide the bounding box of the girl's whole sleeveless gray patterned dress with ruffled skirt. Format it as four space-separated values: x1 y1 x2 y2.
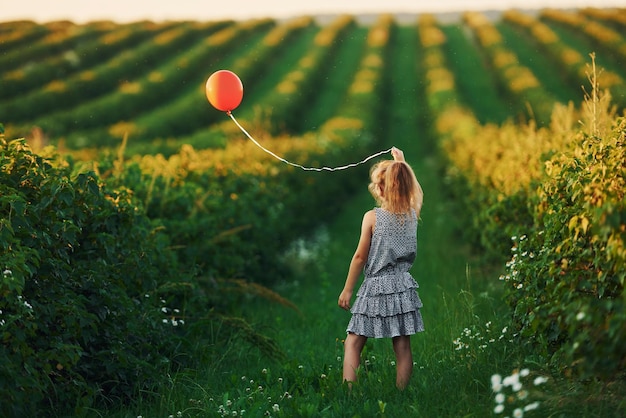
347 208 424 338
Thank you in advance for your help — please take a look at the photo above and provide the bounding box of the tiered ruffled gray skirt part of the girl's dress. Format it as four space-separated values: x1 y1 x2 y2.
347 273 424 338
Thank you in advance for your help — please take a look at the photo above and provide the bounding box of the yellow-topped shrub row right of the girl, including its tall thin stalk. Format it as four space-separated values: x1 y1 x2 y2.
443 58 626 379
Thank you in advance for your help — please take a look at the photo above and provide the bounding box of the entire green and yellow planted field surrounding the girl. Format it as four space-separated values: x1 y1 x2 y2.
0 8 626 417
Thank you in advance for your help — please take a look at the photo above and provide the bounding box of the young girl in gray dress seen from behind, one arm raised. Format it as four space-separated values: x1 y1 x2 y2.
339 147 424 390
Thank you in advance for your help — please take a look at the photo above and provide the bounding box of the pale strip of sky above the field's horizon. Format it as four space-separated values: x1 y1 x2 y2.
0 0 625 23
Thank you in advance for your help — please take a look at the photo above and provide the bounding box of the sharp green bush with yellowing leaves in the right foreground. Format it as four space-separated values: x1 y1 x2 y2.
504 118 626 378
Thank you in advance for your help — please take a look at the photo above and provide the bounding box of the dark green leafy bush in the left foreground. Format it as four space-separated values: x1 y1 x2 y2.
0 132 182 416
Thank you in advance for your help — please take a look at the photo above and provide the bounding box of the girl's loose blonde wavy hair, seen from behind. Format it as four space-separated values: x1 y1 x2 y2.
368 160 424 217
